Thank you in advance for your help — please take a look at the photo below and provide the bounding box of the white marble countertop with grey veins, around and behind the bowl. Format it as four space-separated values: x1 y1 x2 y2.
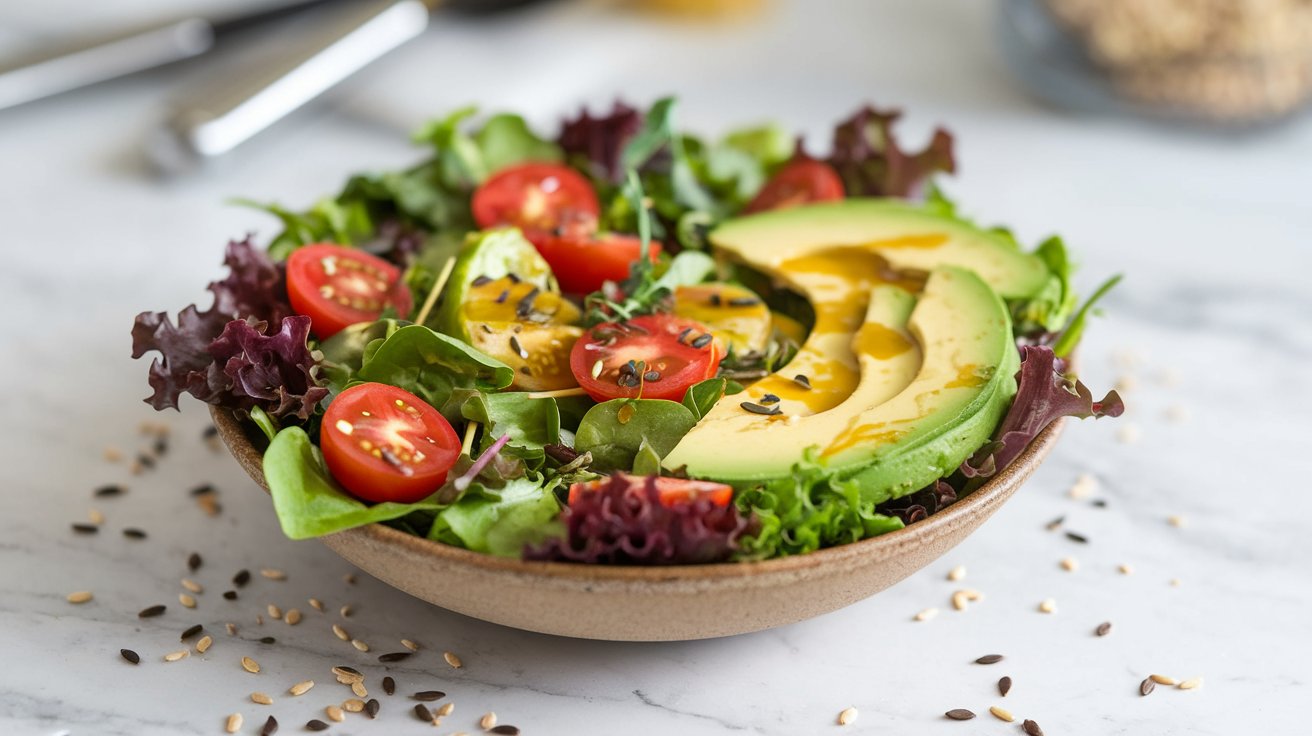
0 0 1312 736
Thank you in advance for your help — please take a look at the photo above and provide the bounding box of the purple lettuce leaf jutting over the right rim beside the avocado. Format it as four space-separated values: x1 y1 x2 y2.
960 345 1126 478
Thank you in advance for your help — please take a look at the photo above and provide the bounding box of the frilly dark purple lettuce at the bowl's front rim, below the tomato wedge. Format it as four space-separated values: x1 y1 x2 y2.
523 472 749 564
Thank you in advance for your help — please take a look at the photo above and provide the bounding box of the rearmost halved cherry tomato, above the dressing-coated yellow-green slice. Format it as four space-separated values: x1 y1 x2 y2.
470 164 601 243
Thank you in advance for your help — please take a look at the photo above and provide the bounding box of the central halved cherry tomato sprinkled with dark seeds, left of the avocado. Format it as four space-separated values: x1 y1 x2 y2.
569 315 724 401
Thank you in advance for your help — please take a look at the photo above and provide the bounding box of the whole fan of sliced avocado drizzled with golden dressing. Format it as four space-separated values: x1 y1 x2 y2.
663 201 1023 502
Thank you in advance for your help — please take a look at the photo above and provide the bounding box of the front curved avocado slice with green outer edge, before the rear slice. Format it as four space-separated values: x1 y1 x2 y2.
664 266 1019 502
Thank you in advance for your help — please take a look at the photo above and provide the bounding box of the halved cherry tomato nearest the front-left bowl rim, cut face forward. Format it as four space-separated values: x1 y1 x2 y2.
319 383 461 504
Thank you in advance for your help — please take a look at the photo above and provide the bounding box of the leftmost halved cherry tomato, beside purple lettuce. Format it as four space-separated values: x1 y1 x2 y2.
287 243 413 340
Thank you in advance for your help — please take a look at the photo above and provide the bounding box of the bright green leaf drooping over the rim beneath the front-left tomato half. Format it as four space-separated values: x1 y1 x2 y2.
264 426 441 539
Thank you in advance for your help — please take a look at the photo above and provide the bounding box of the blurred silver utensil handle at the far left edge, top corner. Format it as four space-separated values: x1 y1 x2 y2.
0 18 214 109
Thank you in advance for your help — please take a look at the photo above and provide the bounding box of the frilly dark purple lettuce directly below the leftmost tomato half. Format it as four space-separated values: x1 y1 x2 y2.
210 315 328 420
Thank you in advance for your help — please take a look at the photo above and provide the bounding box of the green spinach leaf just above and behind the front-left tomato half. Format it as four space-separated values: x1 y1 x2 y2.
357 324 514 422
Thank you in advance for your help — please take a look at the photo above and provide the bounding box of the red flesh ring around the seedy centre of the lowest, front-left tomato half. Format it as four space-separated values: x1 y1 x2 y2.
319 383 461 504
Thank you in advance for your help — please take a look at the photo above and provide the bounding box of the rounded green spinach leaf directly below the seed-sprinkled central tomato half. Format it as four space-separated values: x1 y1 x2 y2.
575 399 697 472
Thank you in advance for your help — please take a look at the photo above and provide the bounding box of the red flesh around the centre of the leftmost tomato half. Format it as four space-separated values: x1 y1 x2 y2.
287 243 413 340
